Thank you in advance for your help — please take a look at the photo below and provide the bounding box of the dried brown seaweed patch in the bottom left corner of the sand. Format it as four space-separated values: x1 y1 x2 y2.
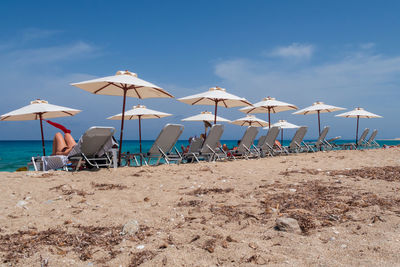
0 225 152 264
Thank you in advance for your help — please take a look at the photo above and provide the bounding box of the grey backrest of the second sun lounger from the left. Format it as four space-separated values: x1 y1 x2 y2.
148 124 183 155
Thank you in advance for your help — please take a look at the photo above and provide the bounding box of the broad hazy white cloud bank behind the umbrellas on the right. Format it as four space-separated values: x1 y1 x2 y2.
215 48 400 138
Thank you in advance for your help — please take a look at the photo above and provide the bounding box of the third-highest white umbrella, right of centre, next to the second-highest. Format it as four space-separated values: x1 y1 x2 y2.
239 96 298 127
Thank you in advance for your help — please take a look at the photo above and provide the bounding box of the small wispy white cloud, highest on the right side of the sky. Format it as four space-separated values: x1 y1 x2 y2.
266 43 315 59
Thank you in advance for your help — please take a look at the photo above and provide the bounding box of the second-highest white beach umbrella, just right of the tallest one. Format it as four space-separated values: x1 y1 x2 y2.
178 86 251 124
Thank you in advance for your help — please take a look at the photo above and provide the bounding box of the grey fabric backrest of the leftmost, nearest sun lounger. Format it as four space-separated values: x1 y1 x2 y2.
79 126 115 157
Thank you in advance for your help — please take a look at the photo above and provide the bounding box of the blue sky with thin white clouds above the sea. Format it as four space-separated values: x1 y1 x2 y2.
0 0 400 140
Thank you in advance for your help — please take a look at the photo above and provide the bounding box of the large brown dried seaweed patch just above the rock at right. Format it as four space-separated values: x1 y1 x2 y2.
261 181 400 233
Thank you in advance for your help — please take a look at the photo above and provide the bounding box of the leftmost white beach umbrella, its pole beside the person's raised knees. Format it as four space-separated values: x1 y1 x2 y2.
0 99 81 156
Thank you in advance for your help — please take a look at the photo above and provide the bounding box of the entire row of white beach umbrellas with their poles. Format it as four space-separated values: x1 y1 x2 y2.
0 71 380 161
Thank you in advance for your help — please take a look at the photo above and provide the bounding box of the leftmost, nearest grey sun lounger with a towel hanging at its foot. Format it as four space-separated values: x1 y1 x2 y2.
32 126 118 171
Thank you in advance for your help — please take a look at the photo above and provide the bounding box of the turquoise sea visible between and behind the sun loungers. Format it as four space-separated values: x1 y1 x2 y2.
0 140 400 172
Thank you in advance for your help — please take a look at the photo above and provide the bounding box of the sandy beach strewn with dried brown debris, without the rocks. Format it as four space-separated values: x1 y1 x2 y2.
0 148 400 266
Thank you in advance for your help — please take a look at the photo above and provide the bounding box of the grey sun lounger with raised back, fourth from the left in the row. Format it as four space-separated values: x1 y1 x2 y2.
229 126 259 159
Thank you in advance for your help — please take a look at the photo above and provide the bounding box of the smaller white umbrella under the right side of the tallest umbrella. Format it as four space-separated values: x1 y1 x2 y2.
107 105 172 153
